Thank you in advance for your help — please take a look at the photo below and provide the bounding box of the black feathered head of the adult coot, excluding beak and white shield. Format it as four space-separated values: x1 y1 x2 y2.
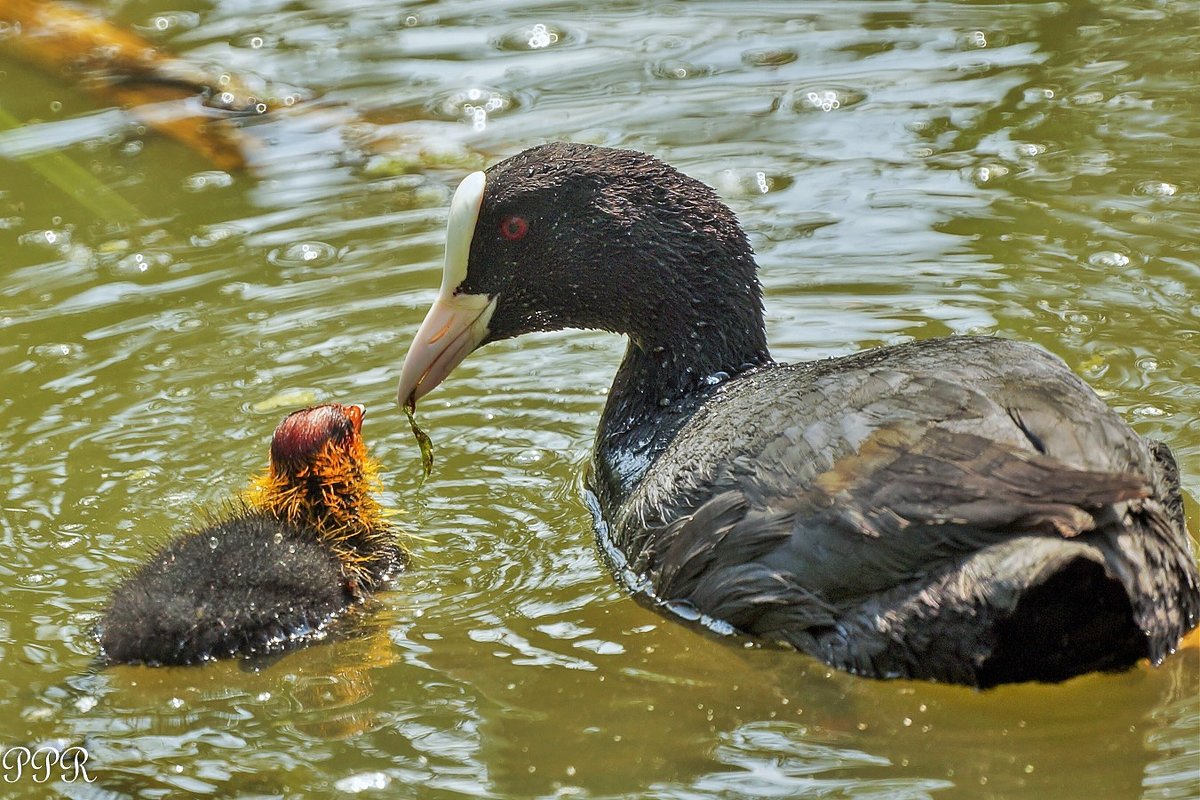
460 143 756 342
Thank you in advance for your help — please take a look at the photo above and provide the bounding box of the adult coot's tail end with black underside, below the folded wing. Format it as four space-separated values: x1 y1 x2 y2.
806 530 1200 687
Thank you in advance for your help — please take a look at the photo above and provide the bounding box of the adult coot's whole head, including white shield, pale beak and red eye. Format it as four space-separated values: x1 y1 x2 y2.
400 143 766 403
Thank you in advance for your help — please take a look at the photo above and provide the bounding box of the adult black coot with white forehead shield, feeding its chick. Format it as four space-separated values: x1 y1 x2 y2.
400 144 1200 686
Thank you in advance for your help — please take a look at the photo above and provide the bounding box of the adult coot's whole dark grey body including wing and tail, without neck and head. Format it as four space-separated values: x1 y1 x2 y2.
606 337 1200 682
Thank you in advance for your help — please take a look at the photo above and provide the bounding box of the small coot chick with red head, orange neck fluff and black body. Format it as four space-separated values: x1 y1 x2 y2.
97 404 404 666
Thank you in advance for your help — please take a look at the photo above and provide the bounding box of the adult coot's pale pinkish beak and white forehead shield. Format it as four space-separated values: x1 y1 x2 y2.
397 173 496 405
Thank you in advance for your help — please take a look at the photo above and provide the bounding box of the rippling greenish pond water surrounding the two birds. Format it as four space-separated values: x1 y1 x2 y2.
0 0 1200 800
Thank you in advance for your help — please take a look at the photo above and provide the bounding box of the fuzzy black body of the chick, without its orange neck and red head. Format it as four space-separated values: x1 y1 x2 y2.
100 510 355 664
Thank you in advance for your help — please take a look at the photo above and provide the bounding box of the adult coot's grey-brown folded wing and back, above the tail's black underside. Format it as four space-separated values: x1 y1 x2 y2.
614 338 1195 662
